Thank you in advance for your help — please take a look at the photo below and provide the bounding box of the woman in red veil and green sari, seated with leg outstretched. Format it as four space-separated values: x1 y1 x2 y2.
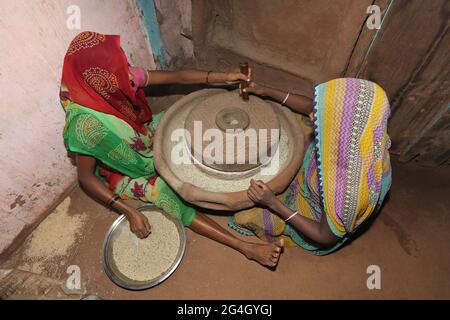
60 32 283 266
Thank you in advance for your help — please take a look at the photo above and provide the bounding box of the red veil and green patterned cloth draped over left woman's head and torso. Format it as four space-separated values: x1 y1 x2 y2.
60 31 155 178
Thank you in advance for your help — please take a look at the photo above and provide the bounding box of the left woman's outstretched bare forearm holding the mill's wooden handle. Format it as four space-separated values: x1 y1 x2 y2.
147 70 249 85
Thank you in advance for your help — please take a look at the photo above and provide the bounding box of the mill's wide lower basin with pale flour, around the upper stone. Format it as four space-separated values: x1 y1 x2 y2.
153 89 306 211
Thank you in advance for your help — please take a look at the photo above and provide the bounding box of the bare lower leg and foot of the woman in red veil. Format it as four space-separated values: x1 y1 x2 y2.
189 212 283 267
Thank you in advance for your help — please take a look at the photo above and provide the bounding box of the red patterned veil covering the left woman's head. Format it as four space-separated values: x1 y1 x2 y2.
60 31 152 131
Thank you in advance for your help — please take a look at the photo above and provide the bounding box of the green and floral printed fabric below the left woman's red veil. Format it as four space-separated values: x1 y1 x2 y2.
64 102 195 226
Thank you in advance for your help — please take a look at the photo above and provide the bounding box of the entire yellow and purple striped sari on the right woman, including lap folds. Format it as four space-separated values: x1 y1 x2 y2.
230 78 391 255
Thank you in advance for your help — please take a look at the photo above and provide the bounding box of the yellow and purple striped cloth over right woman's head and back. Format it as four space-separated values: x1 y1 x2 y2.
314 78 391 237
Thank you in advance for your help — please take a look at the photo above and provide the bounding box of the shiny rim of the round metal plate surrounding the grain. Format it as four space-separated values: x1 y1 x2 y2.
103 205 186 290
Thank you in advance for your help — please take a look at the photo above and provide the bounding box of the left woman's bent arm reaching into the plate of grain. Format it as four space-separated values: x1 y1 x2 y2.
76 153 151 238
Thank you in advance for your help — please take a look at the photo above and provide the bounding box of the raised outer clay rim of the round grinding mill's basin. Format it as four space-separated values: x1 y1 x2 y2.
153 89 305 211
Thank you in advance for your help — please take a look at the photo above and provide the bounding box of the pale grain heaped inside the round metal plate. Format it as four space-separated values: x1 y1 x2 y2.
112 211 180 281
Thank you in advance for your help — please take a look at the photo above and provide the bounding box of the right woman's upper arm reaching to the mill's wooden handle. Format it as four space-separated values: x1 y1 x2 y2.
243 82 313 116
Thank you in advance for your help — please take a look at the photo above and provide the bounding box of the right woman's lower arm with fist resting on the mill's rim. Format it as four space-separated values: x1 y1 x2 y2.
247 180 339 247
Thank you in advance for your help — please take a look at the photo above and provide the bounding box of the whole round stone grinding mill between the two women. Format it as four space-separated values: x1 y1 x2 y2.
154 74 305 211
